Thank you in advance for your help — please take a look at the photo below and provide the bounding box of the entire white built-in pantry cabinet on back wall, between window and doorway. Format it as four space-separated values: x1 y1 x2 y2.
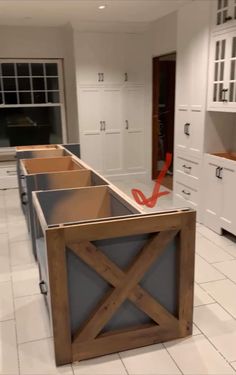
75 33 147 175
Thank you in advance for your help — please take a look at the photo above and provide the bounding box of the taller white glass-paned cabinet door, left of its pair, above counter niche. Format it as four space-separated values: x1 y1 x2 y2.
208 34 229 109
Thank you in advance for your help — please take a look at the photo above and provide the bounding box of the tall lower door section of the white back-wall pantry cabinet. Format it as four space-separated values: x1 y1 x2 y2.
79 85 145 175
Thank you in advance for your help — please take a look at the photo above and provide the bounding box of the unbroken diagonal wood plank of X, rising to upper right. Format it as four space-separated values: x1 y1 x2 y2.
77 231 176 341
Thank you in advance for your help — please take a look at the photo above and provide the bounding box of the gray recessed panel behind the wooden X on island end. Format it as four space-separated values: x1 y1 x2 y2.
67 235 177 334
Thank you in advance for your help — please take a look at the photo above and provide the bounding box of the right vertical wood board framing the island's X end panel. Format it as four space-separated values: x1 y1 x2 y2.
178 212 196 335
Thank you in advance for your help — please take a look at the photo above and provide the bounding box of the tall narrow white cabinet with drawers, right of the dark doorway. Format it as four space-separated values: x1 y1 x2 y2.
174 1 210 220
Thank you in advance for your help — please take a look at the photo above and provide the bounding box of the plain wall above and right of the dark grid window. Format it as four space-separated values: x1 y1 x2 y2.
0 26 78 142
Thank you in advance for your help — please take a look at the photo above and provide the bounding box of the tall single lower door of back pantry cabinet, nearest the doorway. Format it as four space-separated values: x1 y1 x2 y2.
123 87 145 172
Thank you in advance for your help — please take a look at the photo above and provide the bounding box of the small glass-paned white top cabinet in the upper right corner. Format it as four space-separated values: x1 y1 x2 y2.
212 0 236 31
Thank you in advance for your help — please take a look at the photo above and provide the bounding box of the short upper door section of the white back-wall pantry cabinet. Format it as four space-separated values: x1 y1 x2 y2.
75 33 146 85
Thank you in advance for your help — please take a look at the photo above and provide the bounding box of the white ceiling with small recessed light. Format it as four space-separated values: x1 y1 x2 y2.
0 0 190 28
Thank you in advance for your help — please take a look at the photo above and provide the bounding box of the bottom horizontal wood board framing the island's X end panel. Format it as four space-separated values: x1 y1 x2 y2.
72 326 179 361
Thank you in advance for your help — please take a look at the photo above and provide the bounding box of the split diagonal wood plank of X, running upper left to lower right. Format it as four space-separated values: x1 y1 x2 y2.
70 238 178 338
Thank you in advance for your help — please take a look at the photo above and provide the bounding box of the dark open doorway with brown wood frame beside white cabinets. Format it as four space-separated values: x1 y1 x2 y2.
152 52 176 190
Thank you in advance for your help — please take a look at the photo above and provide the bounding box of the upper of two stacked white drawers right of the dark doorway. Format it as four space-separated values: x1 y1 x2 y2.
175 154 201 180
